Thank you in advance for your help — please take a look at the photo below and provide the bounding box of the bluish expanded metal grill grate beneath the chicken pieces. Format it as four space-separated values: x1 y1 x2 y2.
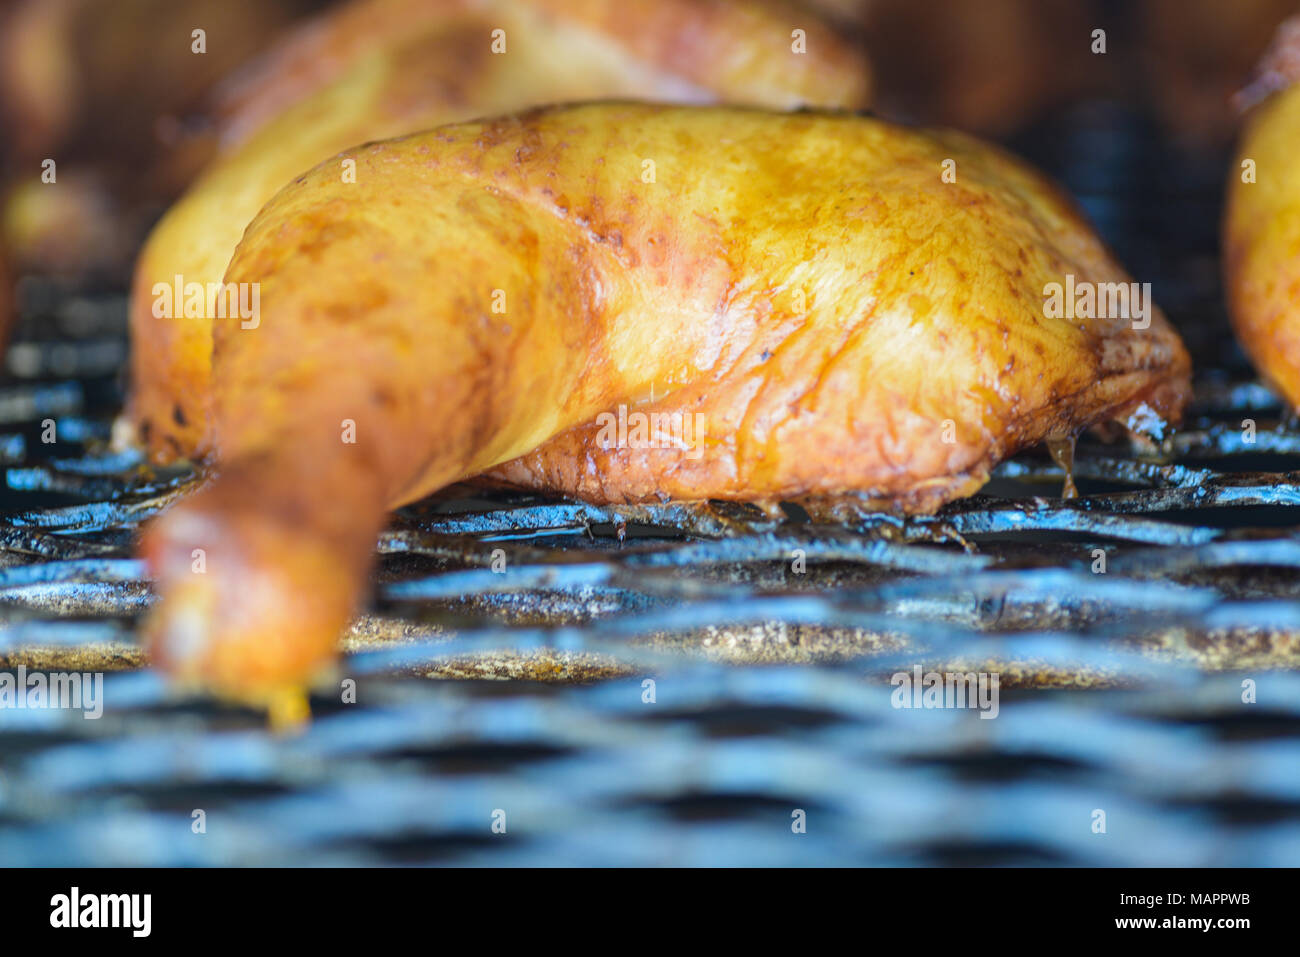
0 107 1300 865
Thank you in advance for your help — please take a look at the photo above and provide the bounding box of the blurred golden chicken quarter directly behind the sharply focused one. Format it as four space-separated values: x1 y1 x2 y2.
129 0 868 462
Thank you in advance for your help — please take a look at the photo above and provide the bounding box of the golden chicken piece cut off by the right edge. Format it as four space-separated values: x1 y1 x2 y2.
1223 18 1300 408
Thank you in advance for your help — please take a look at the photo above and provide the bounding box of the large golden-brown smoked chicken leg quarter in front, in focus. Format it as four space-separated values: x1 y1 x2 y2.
143 104 1188 701
